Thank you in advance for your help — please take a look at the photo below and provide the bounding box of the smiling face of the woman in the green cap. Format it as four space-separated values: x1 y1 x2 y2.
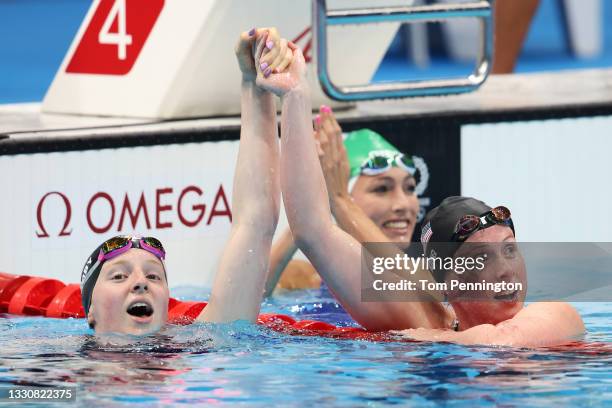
351 167 419 247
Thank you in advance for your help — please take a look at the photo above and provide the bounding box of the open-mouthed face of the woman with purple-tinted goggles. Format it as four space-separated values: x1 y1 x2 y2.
87 249 170 335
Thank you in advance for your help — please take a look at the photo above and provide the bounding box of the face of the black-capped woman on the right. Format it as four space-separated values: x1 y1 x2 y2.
446 225 527 324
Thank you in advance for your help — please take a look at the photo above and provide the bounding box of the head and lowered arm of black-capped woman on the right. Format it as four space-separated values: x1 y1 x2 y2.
394 197 585 347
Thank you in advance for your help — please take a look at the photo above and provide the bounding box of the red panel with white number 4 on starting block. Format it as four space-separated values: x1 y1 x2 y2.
66 0 164 75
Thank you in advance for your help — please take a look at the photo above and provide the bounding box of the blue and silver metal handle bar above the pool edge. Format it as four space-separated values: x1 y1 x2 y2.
312 0 494 101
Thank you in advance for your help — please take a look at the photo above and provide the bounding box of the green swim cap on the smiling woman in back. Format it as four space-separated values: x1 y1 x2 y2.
344 129 400 178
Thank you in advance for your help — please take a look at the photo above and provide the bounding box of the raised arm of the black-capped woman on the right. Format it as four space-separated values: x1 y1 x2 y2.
262 49 450 330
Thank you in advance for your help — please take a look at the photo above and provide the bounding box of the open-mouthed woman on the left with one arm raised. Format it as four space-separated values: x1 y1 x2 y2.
81 29 293 335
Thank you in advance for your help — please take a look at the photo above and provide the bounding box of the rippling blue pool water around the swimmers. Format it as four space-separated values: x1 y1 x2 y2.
0 291 612 407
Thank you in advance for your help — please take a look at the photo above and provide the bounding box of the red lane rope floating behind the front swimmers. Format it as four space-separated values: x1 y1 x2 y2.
0 272 368 340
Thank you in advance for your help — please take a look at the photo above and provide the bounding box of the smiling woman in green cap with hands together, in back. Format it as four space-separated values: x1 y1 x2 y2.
265 113 419 296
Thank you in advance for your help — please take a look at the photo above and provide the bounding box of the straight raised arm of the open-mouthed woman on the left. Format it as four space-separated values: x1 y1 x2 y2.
198 30 292 322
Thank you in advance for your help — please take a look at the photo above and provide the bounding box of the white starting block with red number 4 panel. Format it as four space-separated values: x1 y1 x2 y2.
42 0 406 119
